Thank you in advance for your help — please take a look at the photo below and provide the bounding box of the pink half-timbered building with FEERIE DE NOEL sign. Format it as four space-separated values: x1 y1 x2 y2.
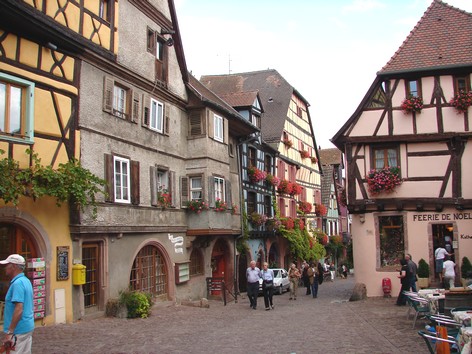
332 0 472 296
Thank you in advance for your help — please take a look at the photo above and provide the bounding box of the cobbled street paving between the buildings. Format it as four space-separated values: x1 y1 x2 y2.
33 277 428 354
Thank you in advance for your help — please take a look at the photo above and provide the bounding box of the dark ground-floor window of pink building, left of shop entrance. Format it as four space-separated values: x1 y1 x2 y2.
378 215 405 271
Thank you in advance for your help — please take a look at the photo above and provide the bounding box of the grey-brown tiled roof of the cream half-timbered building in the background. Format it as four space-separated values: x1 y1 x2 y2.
200 70 302 143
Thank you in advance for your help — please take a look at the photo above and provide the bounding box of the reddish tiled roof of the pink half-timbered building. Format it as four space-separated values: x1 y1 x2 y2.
379 0 472 74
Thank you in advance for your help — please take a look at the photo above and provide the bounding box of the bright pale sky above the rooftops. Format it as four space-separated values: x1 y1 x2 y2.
174 0 472 149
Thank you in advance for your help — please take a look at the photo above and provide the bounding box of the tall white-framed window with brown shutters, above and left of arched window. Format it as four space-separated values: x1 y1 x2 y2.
105 154 139 205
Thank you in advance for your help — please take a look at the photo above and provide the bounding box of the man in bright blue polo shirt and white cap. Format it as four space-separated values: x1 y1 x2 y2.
0 254 34 353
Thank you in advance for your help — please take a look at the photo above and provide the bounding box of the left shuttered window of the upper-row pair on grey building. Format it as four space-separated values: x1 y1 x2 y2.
103 76 140 123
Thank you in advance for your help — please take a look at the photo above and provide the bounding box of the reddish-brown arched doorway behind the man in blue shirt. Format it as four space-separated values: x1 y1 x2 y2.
0 223 39 301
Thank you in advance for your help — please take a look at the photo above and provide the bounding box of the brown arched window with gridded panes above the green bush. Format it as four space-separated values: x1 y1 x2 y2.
130 245 167 296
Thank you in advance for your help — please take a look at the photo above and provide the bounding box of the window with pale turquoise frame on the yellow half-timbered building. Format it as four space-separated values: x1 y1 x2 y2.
0 73 34 142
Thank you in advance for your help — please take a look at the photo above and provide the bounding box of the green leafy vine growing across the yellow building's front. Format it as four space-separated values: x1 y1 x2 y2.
0 149 106 217
